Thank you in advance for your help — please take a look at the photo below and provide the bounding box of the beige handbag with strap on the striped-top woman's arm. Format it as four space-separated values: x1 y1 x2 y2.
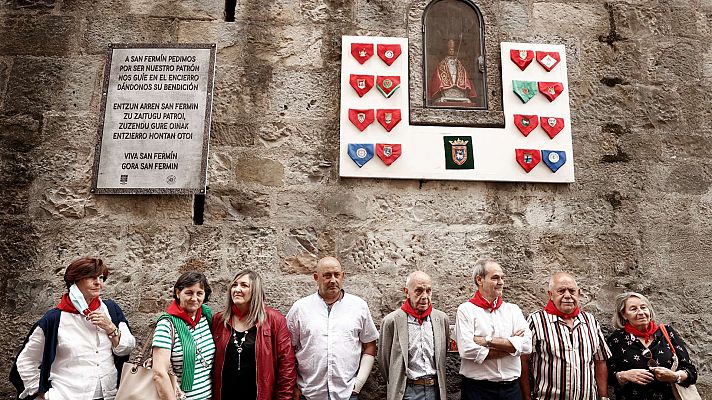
115 324 185 400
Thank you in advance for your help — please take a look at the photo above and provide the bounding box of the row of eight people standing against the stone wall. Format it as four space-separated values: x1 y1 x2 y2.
13 257 697 400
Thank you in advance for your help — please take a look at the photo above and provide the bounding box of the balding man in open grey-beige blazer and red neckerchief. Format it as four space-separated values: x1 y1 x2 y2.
378 271 450 400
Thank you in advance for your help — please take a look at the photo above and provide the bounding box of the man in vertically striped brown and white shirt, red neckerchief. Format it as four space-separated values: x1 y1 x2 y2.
520 272 611 400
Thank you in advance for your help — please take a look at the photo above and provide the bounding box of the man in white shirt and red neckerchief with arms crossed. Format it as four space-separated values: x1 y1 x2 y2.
455 259 532 400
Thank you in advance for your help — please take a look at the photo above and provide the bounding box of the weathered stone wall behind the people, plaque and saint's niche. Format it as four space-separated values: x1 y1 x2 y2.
0 0 712 400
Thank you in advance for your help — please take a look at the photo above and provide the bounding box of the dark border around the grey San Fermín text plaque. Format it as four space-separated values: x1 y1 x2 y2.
91 43 217 195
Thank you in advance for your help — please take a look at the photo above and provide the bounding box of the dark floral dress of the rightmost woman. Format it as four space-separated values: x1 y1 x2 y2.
606 325 697 400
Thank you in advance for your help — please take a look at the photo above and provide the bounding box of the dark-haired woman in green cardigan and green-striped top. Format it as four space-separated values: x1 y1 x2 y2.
153 271 215 400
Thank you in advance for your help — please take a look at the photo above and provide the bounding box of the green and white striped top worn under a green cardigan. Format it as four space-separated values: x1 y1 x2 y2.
153 316 215 400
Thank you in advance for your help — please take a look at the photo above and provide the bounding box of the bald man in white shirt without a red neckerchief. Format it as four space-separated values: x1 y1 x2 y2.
287 257 378 400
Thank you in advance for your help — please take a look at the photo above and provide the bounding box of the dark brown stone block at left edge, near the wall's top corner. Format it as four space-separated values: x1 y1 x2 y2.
0 14 81 56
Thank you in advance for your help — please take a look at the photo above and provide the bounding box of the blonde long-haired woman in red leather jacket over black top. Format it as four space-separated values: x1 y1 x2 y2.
212 269 297 400
